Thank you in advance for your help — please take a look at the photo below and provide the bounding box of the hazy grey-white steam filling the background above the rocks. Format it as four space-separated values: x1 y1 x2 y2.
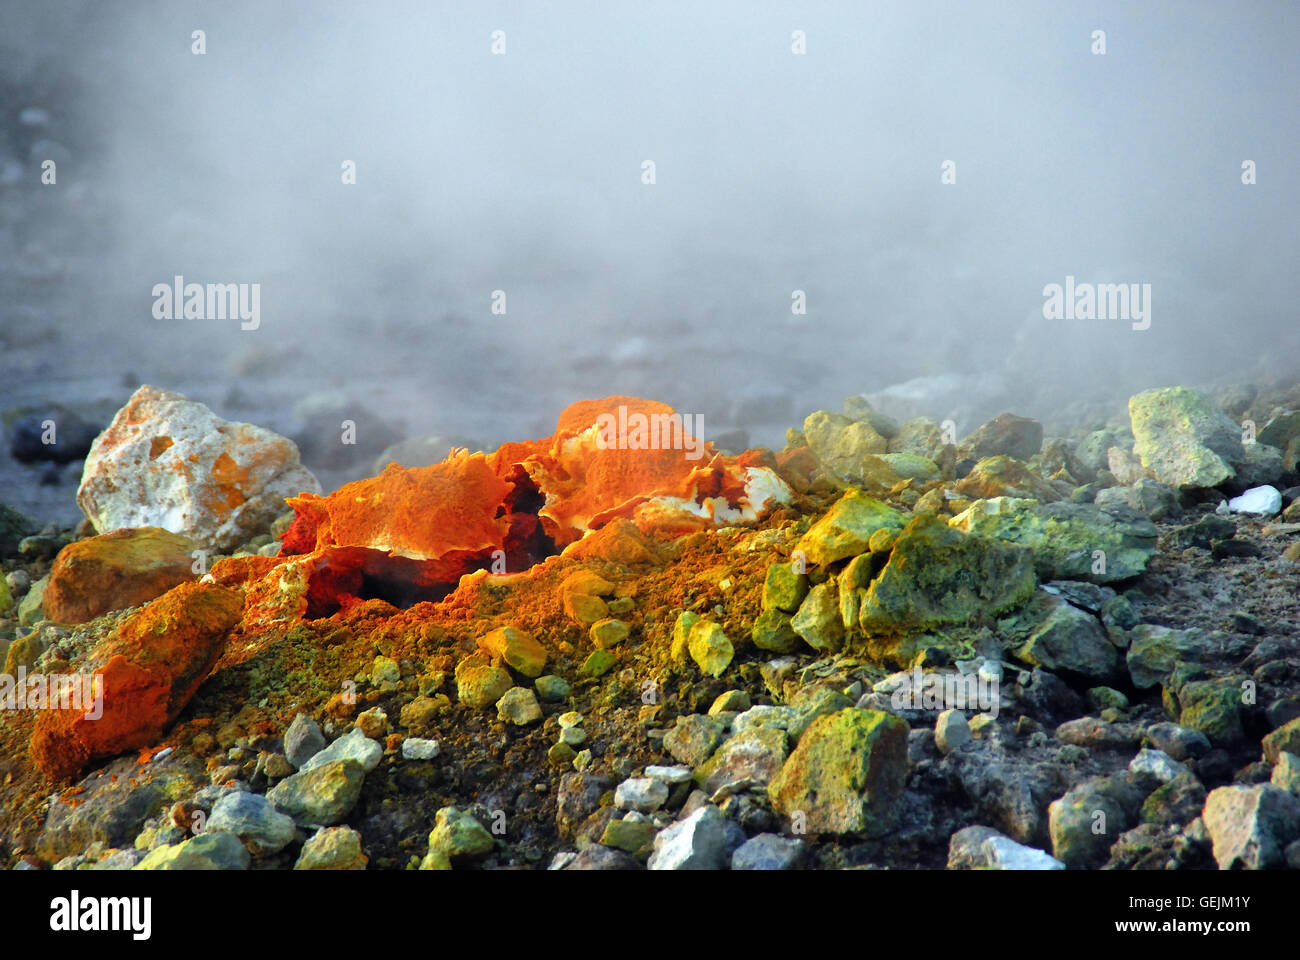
0 0 1300 520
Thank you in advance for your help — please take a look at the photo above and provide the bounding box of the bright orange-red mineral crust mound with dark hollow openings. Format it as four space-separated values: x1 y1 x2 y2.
262 397 792 613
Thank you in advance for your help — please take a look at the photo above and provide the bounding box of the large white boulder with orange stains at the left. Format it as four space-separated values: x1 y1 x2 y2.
77 386 321 552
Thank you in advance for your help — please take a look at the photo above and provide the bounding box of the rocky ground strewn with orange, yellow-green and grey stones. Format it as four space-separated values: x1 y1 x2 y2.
0 377 1300 869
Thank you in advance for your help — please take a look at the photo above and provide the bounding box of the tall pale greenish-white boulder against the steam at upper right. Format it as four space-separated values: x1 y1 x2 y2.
1128 386 1245 488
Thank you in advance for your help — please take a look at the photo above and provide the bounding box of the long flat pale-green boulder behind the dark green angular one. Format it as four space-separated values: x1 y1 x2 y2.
950 497 1157 583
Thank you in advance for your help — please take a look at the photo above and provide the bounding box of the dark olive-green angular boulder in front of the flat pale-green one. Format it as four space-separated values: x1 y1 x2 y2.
857 514 1036 633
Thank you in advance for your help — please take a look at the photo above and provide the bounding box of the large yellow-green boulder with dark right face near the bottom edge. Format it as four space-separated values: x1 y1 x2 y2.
767 706 907 836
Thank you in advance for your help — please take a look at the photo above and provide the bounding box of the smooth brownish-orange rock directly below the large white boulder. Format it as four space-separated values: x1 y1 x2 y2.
43 527 195 623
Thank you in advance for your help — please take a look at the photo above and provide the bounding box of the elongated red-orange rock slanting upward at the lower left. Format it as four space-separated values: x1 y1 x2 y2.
30 574 243 779
